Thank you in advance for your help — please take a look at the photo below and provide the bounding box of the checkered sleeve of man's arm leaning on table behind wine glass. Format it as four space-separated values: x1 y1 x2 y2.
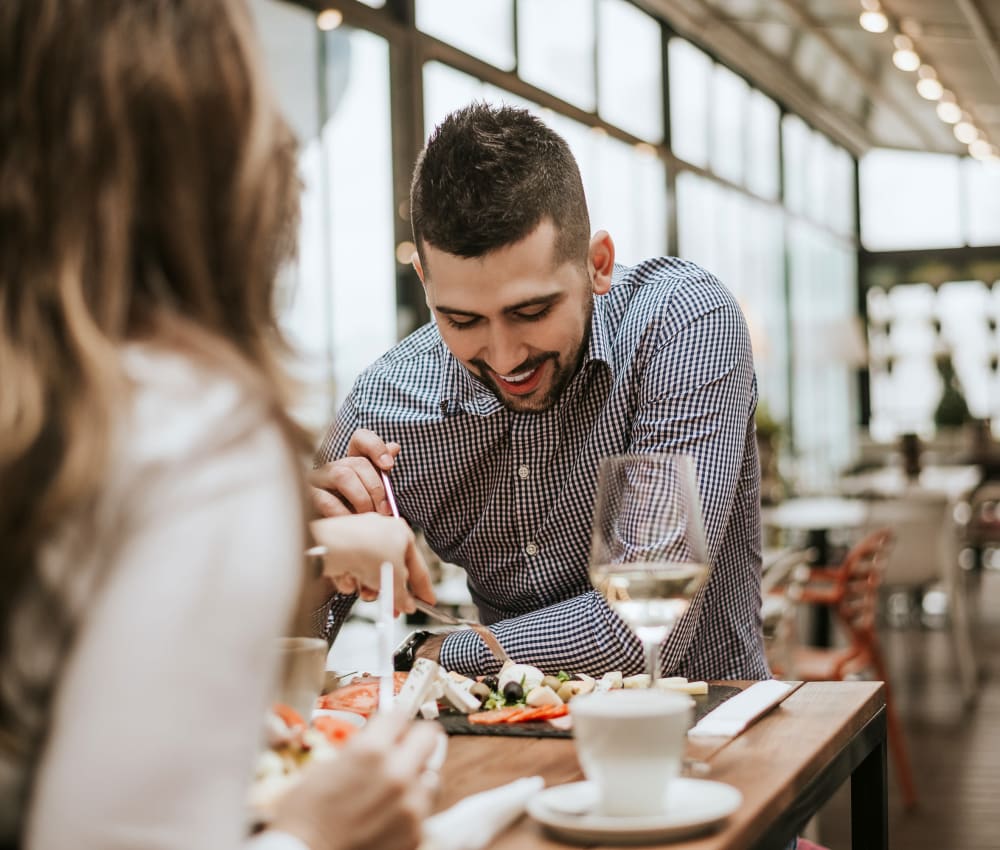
441 300 760 678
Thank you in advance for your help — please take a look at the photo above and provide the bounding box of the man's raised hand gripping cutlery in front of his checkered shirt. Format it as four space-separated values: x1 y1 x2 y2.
309 428 400 516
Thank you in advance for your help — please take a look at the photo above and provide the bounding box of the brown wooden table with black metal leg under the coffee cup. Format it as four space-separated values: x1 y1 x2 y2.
438 682 889 850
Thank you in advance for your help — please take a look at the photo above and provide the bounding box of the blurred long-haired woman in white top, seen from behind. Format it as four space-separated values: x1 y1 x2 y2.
0 0 436 850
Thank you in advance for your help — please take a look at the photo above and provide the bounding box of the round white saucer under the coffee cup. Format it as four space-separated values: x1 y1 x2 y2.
528 777 743 844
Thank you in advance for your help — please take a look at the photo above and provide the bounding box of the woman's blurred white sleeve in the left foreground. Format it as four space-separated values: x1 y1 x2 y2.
24 414 302 850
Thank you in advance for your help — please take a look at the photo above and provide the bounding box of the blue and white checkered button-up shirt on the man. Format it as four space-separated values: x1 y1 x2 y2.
316 257 769 679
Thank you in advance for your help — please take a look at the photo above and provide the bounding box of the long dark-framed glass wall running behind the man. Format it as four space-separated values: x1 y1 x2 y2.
252 0 868 485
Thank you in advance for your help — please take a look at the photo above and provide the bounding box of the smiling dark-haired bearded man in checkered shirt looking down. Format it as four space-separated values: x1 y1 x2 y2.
313 104 768 679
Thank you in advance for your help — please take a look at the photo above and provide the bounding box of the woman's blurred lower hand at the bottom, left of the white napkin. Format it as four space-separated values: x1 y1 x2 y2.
271 712 443 850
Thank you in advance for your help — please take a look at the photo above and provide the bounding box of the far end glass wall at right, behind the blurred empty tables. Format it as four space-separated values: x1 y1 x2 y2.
860 150 1000 442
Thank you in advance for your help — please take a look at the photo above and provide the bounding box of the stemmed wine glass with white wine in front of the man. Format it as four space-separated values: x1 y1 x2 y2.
590 454 711 684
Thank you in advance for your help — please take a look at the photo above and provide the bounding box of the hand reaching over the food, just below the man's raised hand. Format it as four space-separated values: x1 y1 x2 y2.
309 513 434 613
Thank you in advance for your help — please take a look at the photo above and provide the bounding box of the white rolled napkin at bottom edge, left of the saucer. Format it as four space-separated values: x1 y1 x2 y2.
420 776 545 850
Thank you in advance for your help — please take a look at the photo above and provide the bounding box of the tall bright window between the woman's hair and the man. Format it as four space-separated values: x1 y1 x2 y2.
252 0 396 428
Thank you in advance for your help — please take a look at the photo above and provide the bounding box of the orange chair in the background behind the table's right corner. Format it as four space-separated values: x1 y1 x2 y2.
775 528 917 808
